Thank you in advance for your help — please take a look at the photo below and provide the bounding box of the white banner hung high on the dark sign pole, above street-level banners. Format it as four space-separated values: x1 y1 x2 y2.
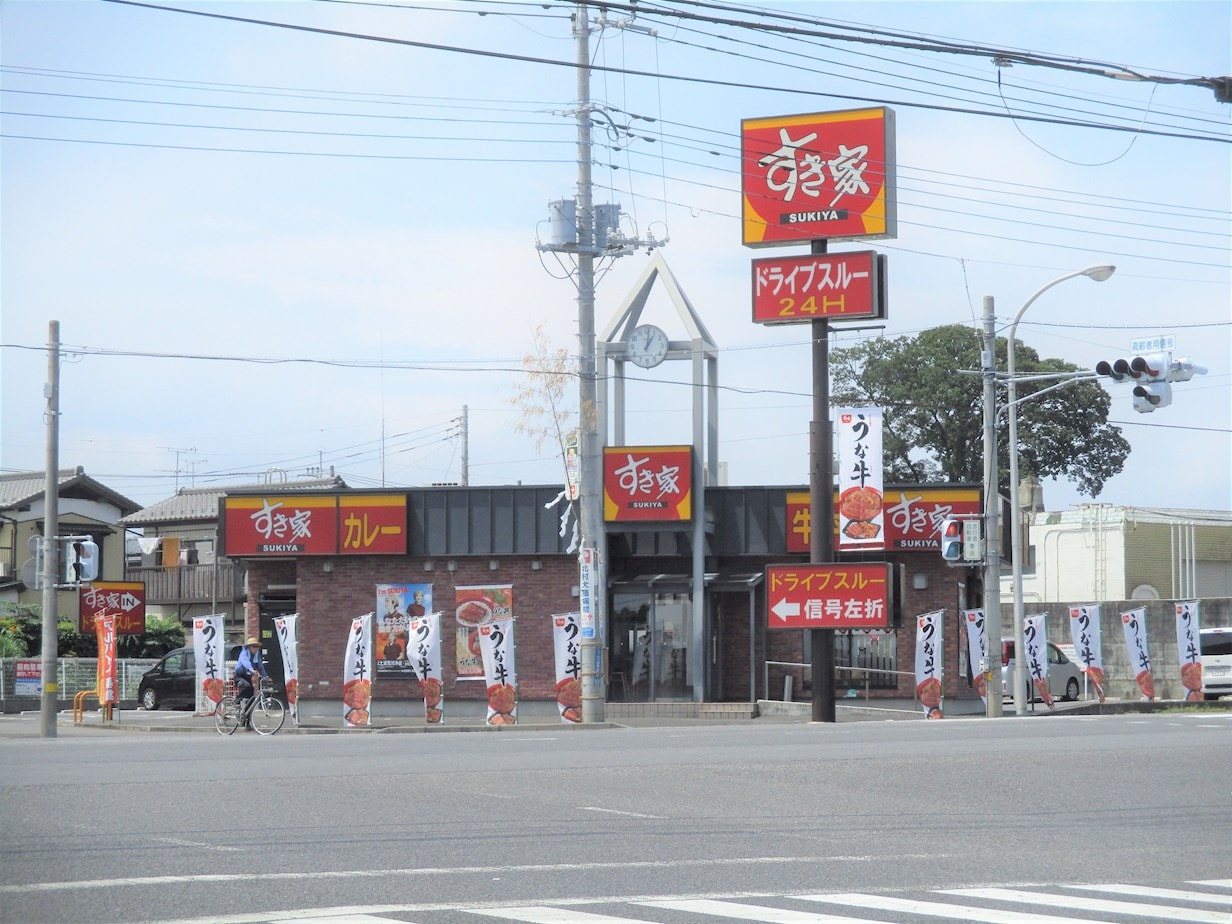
834 408 886 549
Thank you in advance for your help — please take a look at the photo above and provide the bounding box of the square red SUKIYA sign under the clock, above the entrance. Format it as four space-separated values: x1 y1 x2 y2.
604 446 692 522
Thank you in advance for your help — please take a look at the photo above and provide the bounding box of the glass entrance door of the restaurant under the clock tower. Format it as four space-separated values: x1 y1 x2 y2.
607 585 692 702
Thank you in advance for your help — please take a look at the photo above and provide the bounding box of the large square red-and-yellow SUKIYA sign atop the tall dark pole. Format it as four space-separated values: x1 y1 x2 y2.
740 107 897 246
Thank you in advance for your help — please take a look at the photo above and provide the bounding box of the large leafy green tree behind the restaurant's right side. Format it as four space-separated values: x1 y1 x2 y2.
830 324 1130 498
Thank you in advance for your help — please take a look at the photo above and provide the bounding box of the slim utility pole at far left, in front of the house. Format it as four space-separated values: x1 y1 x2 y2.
38 320 60 738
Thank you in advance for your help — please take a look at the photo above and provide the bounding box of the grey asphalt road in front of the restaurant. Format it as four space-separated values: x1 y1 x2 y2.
0 712 1232 924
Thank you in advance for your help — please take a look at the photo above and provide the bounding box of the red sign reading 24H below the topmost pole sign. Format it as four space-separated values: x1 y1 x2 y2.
753 250 886 324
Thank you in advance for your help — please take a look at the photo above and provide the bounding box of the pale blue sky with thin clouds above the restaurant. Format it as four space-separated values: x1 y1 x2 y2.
0 0 1232 510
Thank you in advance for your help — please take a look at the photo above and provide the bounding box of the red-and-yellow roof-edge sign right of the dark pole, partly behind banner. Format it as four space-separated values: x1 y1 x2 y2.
787 488 983 552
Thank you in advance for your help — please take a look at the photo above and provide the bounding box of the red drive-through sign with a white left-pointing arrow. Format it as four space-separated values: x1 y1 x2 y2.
766 562 892 628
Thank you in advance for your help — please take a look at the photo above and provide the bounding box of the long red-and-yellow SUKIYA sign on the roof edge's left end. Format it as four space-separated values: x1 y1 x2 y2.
222 494 407 558
